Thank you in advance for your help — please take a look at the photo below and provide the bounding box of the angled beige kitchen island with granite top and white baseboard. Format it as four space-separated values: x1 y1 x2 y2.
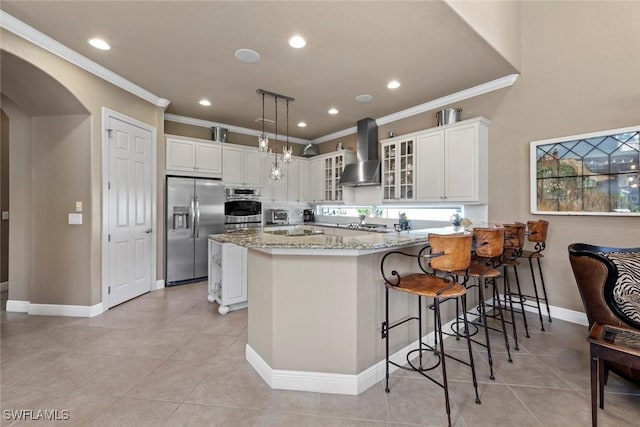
211 227 464 394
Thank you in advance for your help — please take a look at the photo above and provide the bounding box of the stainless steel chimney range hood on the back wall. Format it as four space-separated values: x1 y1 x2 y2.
339 118 380 187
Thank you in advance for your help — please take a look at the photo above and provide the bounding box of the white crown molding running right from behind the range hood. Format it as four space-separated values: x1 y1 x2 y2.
311 74 519 144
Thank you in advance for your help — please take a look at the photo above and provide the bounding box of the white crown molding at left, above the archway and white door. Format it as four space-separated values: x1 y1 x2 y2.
0 10 171 108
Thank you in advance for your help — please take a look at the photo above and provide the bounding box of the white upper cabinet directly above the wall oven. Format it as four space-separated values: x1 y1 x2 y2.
222 144 263 187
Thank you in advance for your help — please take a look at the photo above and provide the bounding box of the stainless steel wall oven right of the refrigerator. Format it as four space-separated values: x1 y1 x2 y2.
224 187 262 232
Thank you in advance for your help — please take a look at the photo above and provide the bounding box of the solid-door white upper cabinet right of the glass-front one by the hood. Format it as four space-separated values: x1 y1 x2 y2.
416 117 489 203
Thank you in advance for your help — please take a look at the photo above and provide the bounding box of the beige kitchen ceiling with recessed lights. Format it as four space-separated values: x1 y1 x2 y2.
0 0 516 140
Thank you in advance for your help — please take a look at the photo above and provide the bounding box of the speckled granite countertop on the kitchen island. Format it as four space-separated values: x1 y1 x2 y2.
209 227 464 250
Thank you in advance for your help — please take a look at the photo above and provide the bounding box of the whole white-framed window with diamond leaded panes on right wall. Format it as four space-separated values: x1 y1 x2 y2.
531 126 640 215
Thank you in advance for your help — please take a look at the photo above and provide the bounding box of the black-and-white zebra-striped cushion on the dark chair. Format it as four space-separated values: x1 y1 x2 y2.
603 251 640 327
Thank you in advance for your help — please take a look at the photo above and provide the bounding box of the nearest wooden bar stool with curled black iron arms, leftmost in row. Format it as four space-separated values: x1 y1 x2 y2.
380 233 480 426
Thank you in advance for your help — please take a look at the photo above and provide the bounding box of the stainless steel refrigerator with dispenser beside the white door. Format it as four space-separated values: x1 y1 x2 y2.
165 176 224 286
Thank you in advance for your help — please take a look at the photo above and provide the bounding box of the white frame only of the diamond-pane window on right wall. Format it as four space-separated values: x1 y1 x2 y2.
529 125 640 217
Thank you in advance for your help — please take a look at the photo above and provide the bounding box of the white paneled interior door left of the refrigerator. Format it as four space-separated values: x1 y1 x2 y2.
105 115 155 308
